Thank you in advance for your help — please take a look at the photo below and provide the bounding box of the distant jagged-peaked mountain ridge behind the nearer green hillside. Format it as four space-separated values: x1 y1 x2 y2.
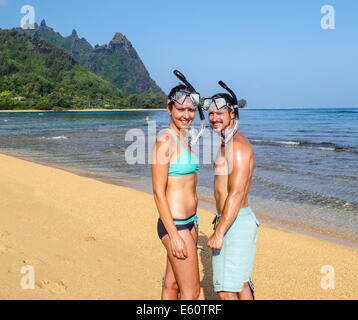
18 20 165 95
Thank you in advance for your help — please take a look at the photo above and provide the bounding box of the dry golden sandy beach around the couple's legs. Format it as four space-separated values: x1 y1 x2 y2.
0 154 358 300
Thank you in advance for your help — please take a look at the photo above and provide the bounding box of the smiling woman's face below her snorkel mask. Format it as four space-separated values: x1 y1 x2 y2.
167 97 195 130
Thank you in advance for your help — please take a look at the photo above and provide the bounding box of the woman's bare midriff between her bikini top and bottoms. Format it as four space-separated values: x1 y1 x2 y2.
166 173 198 219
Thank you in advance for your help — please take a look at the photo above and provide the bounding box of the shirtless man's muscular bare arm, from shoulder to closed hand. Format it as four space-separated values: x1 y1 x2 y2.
207 143 252 250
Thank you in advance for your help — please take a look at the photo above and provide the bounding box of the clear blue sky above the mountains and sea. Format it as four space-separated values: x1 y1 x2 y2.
0 0 358 107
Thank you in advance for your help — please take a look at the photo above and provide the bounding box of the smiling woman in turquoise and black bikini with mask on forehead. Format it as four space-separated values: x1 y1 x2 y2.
152 85 200 300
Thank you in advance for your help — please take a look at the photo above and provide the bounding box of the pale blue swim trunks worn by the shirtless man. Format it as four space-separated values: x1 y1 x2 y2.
212 207 260 292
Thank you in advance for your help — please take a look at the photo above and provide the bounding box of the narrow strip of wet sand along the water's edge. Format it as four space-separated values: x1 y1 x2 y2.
0 149 358 249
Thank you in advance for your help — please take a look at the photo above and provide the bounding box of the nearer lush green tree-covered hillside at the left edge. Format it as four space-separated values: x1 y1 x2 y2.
0 29 127 109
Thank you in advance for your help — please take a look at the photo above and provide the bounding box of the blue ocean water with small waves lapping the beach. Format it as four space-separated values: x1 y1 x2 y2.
0 108 358 240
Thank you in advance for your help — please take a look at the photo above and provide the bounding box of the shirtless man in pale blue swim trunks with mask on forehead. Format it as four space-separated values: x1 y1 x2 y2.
204 89 259 300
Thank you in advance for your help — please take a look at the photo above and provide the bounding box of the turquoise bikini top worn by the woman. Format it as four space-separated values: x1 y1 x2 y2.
168 128 199 177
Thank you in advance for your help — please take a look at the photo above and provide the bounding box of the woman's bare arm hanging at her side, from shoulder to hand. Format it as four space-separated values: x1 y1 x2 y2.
152 135 187 259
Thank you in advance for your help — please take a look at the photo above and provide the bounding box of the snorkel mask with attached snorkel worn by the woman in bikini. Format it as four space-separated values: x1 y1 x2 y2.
168 70 206 147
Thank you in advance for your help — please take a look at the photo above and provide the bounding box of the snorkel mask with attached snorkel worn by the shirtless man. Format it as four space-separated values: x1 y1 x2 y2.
203 81 240 145
